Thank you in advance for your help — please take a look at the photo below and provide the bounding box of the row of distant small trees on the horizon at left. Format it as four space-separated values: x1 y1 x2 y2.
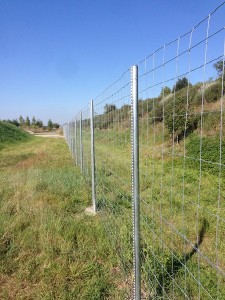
2 116 60 130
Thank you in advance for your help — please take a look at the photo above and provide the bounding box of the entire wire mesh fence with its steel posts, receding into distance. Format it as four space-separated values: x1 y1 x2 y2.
64 3 225 299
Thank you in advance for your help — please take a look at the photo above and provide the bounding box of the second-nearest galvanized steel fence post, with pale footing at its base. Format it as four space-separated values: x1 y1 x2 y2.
90 100 96 212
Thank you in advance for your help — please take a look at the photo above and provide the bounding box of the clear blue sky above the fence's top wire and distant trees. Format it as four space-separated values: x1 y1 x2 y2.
0 0 225 124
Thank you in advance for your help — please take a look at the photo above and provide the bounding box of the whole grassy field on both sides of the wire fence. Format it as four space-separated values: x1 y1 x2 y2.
0 82 225 300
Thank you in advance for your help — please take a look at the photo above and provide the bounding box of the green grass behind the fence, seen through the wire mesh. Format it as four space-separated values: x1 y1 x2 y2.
81 114 225 299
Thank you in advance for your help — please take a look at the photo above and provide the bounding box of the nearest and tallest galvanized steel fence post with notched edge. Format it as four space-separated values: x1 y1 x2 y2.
131 66 141 300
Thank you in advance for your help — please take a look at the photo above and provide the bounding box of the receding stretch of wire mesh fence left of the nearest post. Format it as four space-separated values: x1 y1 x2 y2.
64 70 133 299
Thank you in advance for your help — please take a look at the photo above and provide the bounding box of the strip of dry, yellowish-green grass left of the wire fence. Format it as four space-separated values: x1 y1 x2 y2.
0 138 125 300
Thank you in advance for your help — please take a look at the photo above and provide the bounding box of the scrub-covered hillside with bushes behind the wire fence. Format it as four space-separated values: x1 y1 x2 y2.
95 78 224 141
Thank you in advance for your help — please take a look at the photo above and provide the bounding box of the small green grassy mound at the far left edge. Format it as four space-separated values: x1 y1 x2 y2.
0 121 32 149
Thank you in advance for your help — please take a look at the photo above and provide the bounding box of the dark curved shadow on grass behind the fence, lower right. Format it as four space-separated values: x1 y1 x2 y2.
154 219 209 300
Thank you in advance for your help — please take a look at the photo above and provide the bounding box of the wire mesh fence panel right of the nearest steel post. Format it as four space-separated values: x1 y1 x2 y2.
139 6 225 299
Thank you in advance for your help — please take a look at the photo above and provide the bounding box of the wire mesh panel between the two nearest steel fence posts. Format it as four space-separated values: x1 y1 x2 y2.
94 70 133 299
